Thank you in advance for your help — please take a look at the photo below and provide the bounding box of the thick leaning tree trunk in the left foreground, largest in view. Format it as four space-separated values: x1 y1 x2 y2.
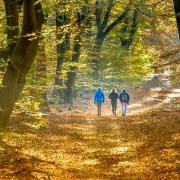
0 0 44 127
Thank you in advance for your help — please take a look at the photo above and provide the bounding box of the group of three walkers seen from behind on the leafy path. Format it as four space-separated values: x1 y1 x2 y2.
94 88 130 116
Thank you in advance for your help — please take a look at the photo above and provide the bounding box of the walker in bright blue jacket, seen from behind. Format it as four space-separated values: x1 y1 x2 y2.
94 88 105 116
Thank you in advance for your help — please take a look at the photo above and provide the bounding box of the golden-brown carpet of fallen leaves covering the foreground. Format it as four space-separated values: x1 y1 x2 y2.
0 111 180 180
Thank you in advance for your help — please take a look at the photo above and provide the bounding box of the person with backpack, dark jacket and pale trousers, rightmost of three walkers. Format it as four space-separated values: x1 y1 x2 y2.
119 89 130 116
